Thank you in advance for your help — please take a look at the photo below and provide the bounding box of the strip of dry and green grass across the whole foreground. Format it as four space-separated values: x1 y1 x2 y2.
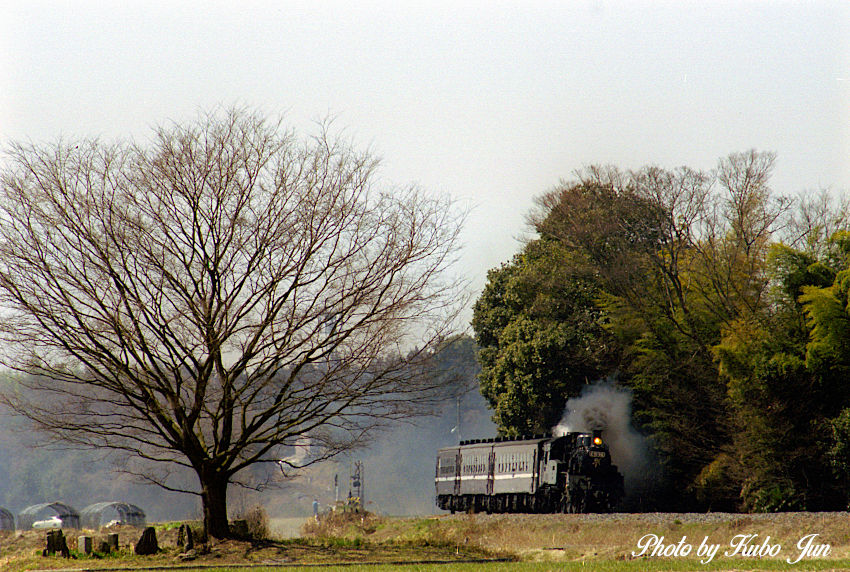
9 513 850 572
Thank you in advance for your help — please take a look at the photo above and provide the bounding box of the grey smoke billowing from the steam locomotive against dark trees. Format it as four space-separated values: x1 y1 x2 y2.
552 380 650 490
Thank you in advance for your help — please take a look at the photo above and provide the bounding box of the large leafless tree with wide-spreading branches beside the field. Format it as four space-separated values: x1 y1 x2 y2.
0 110 463 537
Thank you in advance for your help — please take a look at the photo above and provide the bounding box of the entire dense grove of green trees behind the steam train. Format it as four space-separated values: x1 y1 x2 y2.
473 151 850 510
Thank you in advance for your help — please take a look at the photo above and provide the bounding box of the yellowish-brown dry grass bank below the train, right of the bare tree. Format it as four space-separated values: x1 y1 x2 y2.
367 513 850 561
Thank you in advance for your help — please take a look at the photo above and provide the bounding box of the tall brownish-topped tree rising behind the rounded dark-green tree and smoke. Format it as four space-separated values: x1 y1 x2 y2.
535 167 728 508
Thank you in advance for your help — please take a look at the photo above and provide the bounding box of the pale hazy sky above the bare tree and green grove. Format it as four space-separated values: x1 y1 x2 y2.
0 0 850 324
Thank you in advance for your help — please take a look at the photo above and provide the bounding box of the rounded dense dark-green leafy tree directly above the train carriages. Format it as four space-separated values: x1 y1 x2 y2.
472 237 616 436
